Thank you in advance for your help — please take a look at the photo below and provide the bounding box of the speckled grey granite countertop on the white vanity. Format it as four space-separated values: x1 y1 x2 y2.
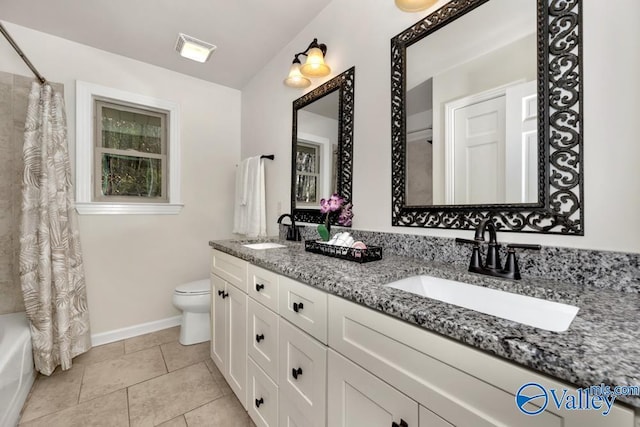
209 239 640 408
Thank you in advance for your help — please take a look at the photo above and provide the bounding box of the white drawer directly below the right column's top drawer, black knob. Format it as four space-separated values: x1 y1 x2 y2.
278 318 327 426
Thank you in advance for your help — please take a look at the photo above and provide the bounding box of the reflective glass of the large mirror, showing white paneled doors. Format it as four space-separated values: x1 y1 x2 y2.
405 0 539 206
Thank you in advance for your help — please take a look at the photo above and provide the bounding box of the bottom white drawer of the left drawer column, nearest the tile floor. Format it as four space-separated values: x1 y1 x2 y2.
247 358 278 427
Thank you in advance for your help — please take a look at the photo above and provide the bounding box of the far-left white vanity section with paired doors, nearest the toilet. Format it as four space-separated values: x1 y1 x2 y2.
211 250 248 408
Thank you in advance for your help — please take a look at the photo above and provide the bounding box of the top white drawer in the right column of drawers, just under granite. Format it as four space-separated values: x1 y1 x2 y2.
279 276 327 344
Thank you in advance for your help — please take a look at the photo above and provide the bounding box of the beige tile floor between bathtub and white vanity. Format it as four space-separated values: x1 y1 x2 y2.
19 327 255 427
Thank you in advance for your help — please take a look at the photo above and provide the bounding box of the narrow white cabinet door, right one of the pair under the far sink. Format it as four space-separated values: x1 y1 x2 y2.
225 284 247 409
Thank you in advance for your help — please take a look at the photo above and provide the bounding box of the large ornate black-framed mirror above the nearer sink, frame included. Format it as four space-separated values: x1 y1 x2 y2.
391 0 584 235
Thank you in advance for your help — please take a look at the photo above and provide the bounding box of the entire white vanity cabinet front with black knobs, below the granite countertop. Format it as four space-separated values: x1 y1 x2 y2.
211 250 640 427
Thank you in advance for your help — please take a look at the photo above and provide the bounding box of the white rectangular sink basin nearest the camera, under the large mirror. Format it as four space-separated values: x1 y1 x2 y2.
386 276 579 332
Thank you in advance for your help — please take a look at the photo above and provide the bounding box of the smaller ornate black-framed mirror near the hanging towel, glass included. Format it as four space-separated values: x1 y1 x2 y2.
291 67 355 223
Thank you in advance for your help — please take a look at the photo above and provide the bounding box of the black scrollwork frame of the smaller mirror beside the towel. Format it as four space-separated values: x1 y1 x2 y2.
291 67 356 225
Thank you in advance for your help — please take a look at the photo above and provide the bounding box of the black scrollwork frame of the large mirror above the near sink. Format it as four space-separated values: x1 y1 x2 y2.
391 0 584 236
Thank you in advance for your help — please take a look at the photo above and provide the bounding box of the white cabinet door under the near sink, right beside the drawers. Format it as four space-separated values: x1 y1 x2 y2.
327 350 418 427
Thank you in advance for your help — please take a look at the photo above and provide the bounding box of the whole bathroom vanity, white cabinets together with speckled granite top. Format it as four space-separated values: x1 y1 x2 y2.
210 241 640 427
